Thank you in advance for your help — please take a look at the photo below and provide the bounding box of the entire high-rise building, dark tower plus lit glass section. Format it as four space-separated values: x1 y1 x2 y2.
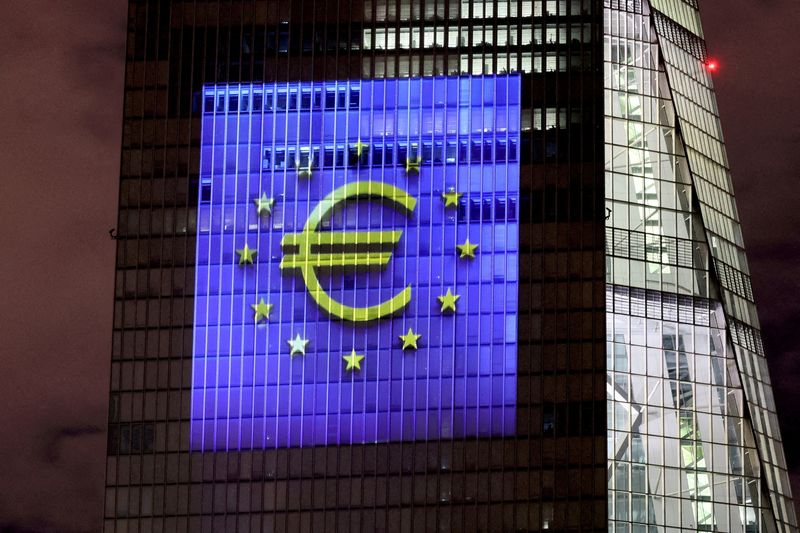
104 0 797 533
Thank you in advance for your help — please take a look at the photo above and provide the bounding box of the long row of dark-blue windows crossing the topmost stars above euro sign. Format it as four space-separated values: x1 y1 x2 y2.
262 139 519 170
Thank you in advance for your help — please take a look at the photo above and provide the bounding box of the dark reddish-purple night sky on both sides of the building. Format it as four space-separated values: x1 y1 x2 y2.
0 0 800 531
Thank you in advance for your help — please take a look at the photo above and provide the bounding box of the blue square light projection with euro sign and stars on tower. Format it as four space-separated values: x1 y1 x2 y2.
191 76 520 450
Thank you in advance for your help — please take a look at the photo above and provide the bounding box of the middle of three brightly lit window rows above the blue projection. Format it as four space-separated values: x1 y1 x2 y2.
362 24 592 50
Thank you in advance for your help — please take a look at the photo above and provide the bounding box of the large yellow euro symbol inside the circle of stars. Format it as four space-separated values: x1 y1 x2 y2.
280 181 417 322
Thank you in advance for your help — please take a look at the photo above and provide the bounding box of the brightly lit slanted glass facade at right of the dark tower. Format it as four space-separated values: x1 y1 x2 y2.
604 0 797 531
